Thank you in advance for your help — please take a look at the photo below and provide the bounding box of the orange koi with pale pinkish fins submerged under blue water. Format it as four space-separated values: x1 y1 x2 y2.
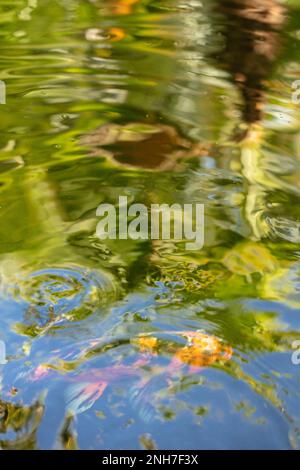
30 331 233 415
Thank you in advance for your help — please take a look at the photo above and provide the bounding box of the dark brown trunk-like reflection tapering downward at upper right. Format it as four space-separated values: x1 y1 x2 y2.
217 0 286 124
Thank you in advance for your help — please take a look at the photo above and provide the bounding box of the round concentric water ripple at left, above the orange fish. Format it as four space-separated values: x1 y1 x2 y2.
1 265 116 334
